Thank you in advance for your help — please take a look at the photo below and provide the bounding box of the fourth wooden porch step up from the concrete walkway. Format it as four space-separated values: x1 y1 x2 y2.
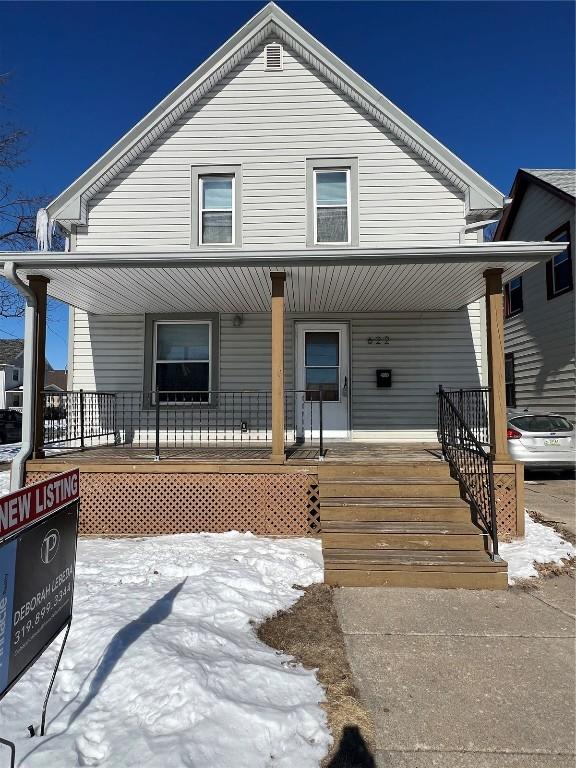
320 477 460 502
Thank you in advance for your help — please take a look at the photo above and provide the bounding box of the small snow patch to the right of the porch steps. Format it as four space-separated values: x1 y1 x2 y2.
499 512 576 584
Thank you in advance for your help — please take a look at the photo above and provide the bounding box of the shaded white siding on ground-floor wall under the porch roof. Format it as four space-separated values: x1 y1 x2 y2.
73 302 482 440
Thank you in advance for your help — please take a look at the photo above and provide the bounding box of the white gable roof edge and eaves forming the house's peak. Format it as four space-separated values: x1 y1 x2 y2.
48 3 504 229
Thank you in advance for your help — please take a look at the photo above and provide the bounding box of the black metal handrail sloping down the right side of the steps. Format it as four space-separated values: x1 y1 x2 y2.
438 387 498 559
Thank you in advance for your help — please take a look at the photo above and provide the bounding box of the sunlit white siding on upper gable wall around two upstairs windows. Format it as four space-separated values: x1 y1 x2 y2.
77 39 466 251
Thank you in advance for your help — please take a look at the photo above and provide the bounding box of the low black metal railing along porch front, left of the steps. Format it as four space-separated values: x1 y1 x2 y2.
43 390 324 459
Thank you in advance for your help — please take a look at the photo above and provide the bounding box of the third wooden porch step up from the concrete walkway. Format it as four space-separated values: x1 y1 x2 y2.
322 496 470 523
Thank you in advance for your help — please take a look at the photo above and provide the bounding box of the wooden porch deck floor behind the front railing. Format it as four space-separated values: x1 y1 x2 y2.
33 441 441 465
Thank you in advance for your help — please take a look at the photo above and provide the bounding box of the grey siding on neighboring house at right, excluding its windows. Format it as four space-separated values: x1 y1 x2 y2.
504 185 576 419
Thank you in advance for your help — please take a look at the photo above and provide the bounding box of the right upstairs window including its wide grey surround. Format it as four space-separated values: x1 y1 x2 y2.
306 157 358 248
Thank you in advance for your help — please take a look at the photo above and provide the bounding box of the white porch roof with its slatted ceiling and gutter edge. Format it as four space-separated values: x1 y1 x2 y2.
0 242 564 314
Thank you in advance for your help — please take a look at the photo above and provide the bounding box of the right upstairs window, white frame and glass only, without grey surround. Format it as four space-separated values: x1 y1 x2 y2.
314 168 350 245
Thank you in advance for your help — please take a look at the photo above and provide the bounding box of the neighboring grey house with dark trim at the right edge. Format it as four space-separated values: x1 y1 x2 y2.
494 169 576 419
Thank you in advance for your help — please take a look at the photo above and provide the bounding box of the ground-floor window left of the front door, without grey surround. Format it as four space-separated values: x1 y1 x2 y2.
152 320 212 403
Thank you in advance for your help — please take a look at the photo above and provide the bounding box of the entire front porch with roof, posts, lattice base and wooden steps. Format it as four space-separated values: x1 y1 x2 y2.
1 244 551 588
